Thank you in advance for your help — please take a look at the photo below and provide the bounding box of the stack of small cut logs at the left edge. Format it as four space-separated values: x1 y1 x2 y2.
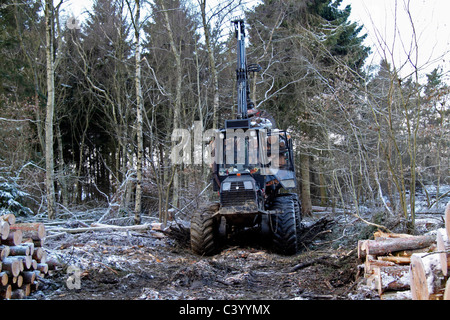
0 214 48 299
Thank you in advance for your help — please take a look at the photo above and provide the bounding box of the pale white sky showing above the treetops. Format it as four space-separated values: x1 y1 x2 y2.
63 0 450 80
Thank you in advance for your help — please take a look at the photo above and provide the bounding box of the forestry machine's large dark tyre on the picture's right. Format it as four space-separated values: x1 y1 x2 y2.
272 196 297 255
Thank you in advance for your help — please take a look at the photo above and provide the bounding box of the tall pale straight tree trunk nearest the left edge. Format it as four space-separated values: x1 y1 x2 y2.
45 0 56 219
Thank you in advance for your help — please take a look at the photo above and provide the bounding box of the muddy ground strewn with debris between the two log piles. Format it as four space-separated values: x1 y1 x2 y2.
29 210 386 300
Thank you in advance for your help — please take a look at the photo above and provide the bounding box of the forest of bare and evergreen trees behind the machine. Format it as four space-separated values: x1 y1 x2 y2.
0 0 450 232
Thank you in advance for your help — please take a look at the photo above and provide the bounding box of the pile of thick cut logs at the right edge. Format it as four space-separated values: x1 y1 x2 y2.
358 203 450 300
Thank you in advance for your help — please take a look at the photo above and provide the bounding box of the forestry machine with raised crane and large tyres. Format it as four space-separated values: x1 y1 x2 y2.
190 19 301 255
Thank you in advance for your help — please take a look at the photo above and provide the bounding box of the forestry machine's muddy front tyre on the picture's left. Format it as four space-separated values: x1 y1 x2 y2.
191 204 219 256
